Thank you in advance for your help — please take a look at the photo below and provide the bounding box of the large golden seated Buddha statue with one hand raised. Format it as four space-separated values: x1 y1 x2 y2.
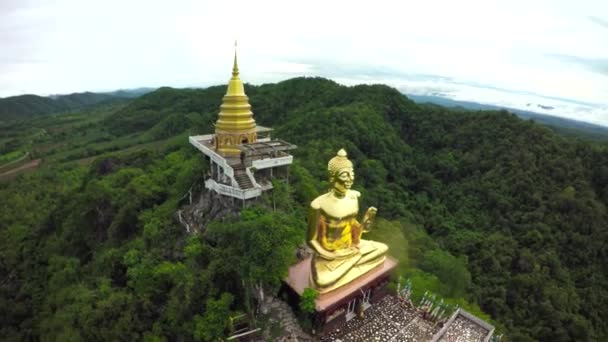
308 149 388 293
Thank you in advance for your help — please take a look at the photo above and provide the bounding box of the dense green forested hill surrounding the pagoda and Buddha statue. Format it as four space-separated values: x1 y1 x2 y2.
0 78 608 341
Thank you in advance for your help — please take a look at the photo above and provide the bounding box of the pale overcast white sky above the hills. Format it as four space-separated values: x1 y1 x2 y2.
0 0 608 126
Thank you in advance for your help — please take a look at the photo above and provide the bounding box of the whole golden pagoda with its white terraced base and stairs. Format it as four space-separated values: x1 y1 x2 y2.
188 44 297 200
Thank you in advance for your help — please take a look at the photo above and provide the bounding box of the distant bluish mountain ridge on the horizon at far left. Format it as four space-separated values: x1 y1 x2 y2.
0 88 154 122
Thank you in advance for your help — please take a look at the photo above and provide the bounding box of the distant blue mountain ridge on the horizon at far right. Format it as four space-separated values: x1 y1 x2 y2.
406 94 608 140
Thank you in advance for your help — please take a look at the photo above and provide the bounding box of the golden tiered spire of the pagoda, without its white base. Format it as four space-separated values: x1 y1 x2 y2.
215 46 257 156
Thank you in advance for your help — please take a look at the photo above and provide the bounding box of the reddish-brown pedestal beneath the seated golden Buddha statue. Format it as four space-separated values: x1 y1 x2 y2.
285 256 397 335
